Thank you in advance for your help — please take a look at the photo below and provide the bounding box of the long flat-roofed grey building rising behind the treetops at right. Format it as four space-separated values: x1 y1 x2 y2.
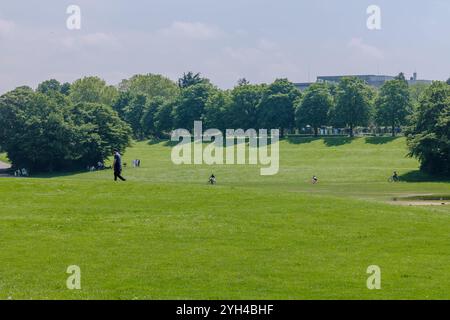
294 72 432 91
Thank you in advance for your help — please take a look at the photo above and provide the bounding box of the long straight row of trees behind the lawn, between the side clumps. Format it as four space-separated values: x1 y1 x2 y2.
107 73 425 139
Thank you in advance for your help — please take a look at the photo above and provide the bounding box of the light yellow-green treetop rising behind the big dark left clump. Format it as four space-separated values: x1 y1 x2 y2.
69 77 118 106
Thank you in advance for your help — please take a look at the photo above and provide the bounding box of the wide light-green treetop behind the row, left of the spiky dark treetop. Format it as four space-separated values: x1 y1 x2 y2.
119 73 178 99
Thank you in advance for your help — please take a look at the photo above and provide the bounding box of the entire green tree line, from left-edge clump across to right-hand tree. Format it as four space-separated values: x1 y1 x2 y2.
0 72 450 175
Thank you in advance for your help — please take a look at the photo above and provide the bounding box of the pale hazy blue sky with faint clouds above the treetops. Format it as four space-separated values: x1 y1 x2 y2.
0 0 450 94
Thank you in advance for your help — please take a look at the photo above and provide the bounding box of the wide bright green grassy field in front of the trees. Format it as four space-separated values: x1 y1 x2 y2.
0 138 450 299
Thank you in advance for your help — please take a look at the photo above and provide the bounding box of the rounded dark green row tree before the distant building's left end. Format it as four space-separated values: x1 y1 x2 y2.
296 83 333 136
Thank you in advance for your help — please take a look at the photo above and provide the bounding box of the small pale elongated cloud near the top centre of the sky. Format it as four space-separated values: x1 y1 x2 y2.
157 21 224 40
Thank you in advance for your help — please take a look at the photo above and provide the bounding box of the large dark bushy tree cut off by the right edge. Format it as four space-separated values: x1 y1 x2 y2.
407 81 450 176
